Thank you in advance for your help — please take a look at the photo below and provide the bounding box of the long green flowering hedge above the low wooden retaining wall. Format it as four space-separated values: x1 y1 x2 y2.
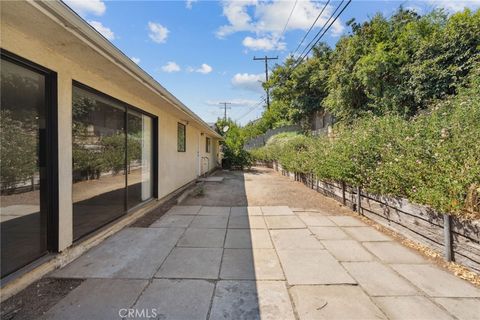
251 82 480 218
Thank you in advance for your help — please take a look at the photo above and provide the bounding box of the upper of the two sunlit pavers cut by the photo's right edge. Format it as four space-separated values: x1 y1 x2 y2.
392 264 480 298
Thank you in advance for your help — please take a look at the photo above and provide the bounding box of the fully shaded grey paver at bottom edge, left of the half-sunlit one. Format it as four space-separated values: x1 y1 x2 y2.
134 279 215 320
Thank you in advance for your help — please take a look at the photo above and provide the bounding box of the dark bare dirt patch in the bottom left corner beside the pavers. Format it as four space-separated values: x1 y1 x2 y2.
0 278 84 320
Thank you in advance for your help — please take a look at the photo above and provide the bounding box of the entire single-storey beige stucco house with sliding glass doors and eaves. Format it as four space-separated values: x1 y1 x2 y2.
0 1 222 286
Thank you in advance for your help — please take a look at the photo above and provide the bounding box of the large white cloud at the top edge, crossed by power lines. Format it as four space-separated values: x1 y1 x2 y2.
216 0 345 43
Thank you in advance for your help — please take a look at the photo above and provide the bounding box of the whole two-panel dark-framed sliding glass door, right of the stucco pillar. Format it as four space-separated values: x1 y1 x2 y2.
72 85 153 240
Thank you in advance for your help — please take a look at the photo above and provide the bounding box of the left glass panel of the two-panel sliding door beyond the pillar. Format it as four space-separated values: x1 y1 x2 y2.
72 87 125 239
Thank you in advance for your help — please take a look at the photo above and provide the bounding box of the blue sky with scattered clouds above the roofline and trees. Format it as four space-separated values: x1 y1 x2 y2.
65 0 480 124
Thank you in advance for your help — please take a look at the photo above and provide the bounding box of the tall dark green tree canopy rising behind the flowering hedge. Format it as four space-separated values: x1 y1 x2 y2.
245 7 480 136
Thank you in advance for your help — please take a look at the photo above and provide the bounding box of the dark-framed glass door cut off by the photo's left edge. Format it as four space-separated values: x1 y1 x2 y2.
0 52 53 278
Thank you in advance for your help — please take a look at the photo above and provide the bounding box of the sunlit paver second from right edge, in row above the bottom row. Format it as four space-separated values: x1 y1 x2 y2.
343 261 419 296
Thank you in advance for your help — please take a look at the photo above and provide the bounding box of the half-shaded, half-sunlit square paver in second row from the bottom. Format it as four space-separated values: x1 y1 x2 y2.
220 249 285 280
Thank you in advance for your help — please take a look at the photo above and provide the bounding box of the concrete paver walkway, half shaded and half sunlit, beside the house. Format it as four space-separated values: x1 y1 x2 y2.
45 169 480 320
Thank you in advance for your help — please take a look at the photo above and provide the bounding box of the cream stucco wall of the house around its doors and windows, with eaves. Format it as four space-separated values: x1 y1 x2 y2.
0 2 222 250
